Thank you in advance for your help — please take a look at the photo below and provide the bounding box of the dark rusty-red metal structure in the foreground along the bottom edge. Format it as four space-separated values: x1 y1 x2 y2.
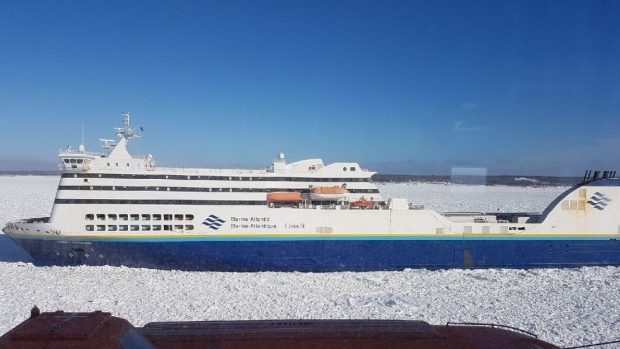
0 308 557 349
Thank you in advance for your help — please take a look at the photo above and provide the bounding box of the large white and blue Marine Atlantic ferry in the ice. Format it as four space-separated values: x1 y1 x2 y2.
3 113 620 271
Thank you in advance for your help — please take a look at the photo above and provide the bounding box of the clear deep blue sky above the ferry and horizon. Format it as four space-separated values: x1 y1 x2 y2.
0 0 620 175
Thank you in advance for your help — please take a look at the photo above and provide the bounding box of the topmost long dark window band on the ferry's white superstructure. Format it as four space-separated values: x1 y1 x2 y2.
62 173 370 182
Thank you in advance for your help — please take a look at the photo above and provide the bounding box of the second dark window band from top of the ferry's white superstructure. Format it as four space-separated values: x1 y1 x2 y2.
58 185 379 194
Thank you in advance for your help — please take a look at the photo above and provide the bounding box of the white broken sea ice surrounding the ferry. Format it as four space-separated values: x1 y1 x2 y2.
0 176 620 348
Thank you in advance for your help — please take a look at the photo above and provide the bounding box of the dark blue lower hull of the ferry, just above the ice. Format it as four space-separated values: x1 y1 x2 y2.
13 237 620 272
